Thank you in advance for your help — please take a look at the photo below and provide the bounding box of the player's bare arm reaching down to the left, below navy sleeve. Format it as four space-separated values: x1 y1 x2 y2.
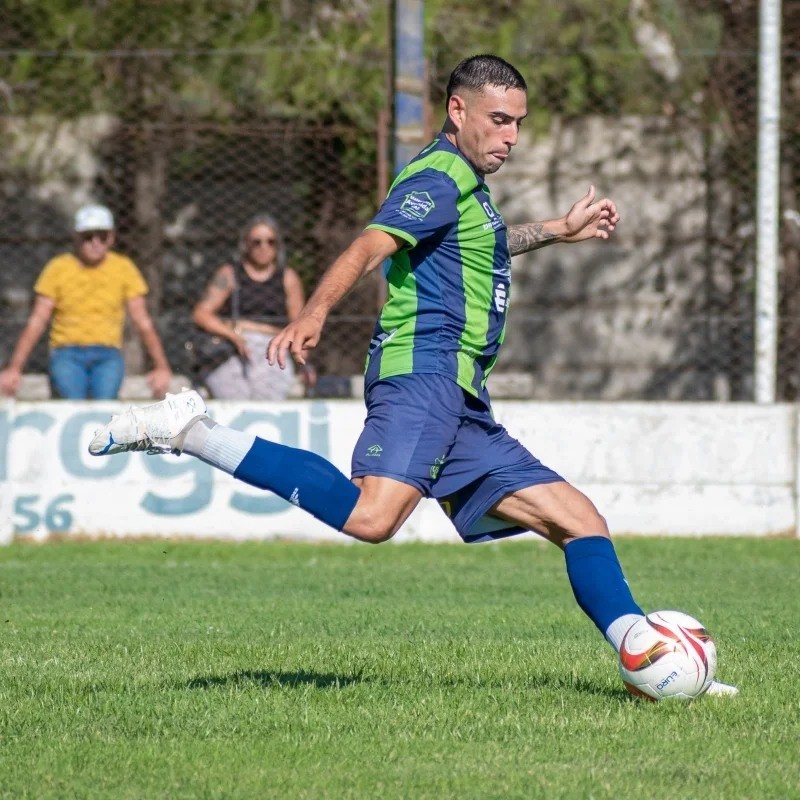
267 228 404 369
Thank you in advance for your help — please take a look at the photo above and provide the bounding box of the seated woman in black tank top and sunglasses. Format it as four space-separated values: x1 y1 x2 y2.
192 214 314 400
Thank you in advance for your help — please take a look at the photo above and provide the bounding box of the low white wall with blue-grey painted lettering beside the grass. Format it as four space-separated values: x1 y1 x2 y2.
0 400 798 543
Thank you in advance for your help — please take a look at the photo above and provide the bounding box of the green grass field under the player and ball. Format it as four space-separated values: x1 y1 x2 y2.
0 539 800 800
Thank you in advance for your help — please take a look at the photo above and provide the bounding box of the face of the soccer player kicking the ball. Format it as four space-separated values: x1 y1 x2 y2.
447 86 528 175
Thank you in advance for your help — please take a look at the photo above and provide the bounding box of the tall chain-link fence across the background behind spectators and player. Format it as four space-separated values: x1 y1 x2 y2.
0 0 800 400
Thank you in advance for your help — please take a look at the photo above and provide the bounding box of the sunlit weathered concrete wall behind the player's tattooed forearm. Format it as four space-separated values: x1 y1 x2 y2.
489 117 753 400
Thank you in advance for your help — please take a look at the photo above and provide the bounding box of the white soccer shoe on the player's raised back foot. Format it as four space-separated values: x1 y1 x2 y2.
89 390 206 456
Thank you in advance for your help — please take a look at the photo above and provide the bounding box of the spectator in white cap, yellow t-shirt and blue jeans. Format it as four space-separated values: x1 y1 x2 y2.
0 205 172 400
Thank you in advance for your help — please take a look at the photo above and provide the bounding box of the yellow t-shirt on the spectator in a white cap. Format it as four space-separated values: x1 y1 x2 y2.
33 251 147 347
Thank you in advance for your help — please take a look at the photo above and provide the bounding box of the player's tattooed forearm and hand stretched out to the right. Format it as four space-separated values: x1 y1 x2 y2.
508 186 620 256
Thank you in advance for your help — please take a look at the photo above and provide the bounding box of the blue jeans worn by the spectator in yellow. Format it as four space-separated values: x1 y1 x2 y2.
50 345 125 400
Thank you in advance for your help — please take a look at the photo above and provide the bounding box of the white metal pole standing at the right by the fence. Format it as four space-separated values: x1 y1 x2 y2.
755 0 781 403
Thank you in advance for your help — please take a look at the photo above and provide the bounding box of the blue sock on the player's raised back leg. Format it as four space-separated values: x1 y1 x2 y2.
233 437 361 531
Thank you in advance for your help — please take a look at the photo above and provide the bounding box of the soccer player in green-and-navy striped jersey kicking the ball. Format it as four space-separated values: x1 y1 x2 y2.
89 55 736 693
